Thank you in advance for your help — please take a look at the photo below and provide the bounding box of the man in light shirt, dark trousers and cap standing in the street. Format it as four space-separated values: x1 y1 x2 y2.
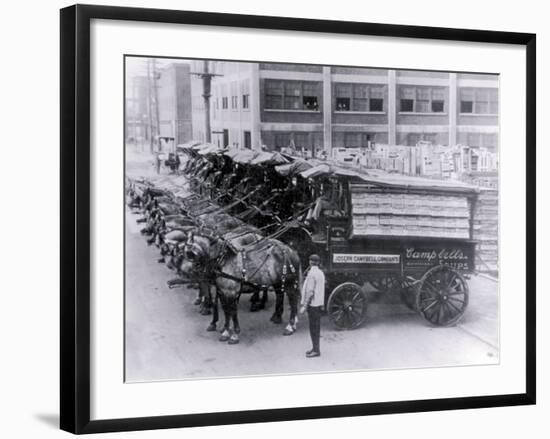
300 254 325 358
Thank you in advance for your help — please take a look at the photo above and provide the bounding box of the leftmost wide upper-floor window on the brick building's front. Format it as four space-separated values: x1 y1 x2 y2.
265 79 320 111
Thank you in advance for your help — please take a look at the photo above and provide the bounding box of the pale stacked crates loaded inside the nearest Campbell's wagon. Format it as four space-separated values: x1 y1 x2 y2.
352 190 470 239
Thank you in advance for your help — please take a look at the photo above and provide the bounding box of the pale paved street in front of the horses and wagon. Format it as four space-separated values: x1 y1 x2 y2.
126 208 498 382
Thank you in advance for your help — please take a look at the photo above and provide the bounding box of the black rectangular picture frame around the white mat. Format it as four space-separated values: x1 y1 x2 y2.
60 5 536 434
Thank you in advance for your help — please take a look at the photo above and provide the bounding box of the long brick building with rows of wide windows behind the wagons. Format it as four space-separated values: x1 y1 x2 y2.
191 61 499 154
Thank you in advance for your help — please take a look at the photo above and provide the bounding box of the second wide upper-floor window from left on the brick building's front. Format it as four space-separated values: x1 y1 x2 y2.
334 83 385 112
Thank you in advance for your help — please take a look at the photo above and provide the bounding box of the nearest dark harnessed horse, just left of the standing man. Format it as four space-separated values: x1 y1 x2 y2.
180 233 302 344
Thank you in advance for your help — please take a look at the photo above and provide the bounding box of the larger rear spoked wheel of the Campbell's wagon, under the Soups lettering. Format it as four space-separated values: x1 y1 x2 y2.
416 265 468 326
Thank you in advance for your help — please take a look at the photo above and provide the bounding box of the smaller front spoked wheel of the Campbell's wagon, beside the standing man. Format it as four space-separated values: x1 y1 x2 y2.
327 282 368 329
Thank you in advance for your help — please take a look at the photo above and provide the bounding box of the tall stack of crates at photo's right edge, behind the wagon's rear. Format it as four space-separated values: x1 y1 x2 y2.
473 188 498 274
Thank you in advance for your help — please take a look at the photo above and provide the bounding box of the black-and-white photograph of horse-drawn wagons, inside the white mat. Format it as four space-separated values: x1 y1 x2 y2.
127 53 501 383
